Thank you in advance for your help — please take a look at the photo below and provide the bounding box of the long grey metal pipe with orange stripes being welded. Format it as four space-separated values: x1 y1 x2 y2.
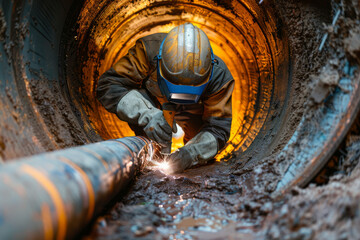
0 137 151 239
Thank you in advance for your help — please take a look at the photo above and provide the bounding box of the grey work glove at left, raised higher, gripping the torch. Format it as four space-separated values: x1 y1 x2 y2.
116 90 177 147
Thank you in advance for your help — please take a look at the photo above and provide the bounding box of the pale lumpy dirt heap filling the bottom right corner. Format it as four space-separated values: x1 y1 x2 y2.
264 169 360 239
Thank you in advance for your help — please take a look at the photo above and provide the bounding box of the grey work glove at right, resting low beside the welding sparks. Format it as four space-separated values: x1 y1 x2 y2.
166 132 218 173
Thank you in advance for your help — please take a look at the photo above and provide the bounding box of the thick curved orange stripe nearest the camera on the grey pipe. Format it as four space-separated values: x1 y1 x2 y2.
21 164 67 240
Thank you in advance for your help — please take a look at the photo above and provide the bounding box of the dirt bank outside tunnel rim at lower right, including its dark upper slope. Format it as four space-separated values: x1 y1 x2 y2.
257 116 360 239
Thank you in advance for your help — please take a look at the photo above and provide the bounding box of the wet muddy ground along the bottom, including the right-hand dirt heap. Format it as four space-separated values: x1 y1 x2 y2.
85 135 360 239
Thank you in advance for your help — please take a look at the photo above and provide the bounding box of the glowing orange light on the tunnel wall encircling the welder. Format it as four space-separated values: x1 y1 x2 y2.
74 0 287 160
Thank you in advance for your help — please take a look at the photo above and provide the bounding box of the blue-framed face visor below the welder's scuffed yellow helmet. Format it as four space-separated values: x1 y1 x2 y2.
156 39 217 104
